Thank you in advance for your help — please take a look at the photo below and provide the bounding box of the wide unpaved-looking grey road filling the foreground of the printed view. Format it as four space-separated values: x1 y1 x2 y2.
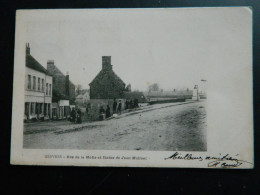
24 101 207 151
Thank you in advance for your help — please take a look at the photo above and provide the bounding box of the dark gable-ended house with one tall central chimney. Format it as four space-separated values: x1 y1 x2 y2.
89 56 125 99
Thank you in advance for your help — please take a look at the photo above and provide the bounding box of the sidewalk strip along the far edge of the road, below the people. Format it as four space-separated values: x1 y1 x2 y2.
24 100 197 134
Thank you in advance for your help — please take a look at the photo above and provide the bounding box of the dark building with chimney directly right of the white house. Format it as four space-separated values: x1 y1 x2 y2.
47 60 75 119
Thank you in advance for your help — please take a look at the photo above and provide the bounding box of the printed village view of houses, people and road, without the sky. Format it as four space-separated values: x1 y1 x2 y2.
23 43 207 151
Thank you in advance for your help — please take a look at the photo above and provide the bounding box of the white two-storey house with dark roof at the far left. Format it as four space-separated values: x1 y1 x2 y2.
24 43 53 120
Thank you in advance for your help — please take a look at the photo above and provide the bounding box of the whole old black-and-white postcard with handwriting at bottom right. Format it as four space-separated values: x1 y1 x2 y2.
11 7 254 168
